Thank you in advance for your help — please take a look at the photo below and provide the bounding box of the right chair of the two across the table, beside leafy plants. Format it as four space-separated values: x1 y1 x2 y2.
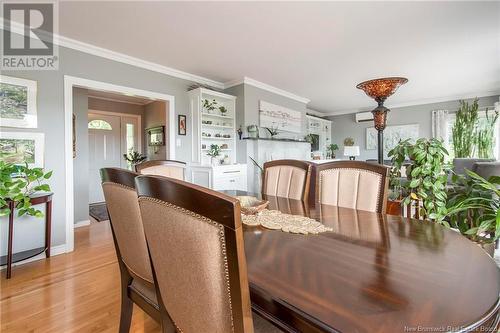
311 161 389 213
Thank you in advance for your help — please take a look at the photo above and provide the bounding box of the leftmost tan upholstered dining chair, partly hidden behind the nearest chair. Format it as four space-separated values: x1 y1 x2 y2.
101 168 160 333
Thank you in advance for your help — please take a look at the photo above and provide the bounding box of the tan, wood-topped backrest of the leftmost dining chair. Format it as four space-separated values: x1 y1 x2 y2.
101 168 153 284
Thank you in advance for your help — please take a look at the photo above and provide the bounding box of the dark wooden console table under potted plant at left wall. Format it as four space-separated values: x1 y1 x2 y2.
0 193 53 279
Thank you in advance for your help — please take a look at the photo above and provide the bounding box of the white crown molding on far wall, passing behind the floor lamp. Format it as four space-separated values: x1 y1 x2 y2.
324 89 500 117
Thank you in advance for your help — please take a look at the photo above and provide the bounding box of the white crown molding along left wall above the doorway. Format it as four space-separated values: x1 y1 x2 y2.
0 18 224 89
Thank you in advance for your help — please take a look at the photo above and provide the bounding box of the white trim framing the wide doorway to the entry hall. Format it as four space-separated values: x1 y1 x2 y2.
64 75 175 252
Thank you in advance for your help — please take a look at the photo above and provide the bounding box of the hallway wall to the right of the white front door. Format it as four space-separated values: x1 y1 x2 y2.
144 101 168 160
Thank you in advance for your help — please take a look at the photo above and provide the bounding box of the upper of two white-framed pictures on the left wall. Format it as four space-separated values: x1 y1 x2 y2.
0 75 37 128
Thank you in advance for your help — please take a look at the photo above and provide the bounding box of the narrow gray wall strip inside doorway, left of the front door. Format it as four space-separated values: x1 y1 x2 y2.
73 88 89 223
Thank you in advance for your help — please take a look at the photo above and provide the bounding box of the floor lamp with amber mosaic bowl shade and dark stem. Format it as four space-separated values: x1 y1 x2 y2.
356 77 408 164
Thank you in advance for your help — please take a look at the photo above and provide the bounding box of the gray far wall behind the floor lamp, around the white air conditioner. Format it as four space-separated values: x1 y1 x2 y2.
328 96 498 160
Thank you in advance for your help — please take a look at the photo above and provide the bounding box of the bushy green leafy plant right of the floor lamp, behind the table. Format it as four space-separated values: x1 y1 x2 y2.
389 138 450 220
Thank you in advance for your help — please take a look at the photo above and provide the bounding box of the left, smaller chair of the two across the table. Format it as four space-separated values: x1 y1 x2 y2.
262 160 311 201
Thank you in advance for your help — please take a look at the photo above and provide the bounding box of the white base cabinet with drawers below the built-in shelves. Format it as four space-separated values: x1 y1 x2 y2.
191 164 247 191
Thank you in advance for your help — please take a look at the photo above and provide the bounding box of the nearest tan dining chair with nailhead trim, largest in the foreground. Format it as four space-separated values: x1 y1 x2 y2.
136 176 279 333
